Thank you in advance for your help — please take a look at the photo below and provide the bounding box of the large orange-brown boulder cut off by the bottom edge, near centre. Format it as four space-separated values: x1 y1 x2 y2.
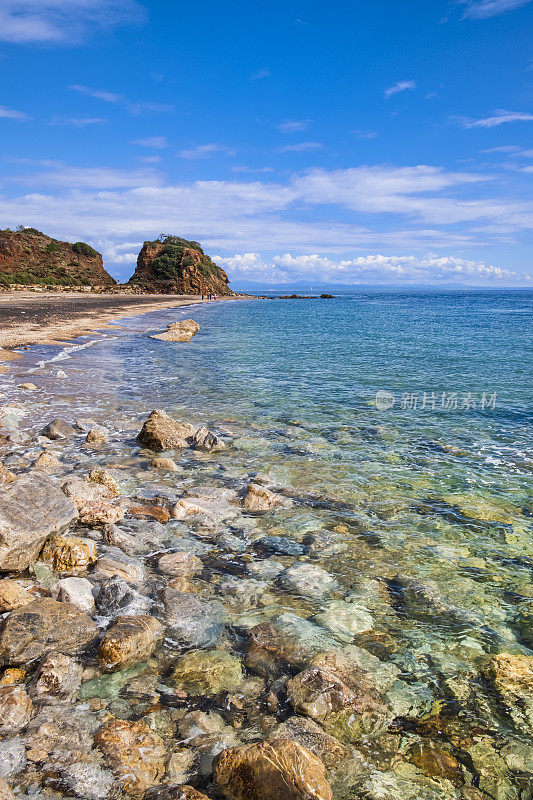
213 739 333 800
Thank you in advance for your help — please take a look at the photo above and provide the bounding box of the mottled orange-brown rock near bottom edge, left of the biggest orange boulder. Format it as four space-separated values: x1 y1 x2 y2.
94 719 166 797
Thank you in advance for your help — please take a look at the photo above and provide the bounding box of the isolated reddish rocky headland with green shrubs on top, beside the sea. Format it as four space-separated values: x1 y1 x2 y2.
129 236 233 294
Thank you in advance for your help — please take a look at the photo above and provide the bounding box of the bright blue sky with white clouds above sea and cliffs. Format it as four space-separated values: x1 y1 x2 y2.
0 0 533 286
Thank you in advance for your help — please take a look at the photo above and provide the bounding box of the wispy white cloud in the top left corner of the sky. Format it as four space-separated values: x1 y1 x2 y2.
0 0 145 44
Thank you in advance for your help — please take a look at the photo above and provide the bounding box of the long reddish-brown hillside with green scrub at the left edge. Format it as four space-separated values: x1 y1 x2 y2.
0 228 116 286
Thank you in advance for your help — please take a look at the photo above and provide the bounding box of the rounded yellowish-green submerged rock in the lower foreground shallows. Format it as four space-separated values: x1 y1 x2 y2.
171 650 243 696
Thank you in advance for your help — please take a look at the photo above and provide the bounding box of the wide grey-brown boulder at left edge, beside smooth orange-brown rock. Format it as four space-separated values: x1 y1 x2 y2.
0 598 98 665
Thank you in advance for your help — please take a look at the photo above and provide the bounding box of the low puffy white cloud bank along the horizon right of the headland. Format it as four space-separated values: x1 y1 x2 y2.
214 252 531 286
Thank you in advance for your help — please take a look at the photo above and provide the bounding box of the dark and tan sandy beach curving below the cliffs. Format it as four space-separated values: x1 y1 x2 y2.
0 292 239 354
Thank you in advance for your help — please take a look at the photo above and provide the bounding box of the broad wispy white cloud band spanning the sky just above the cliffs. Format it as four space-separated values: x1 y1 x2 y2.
0 160 533 279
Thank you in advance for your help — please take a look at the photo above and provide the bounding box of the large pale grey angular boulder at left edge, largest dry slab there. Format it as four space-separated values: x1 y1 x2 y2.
0 472 78 571
